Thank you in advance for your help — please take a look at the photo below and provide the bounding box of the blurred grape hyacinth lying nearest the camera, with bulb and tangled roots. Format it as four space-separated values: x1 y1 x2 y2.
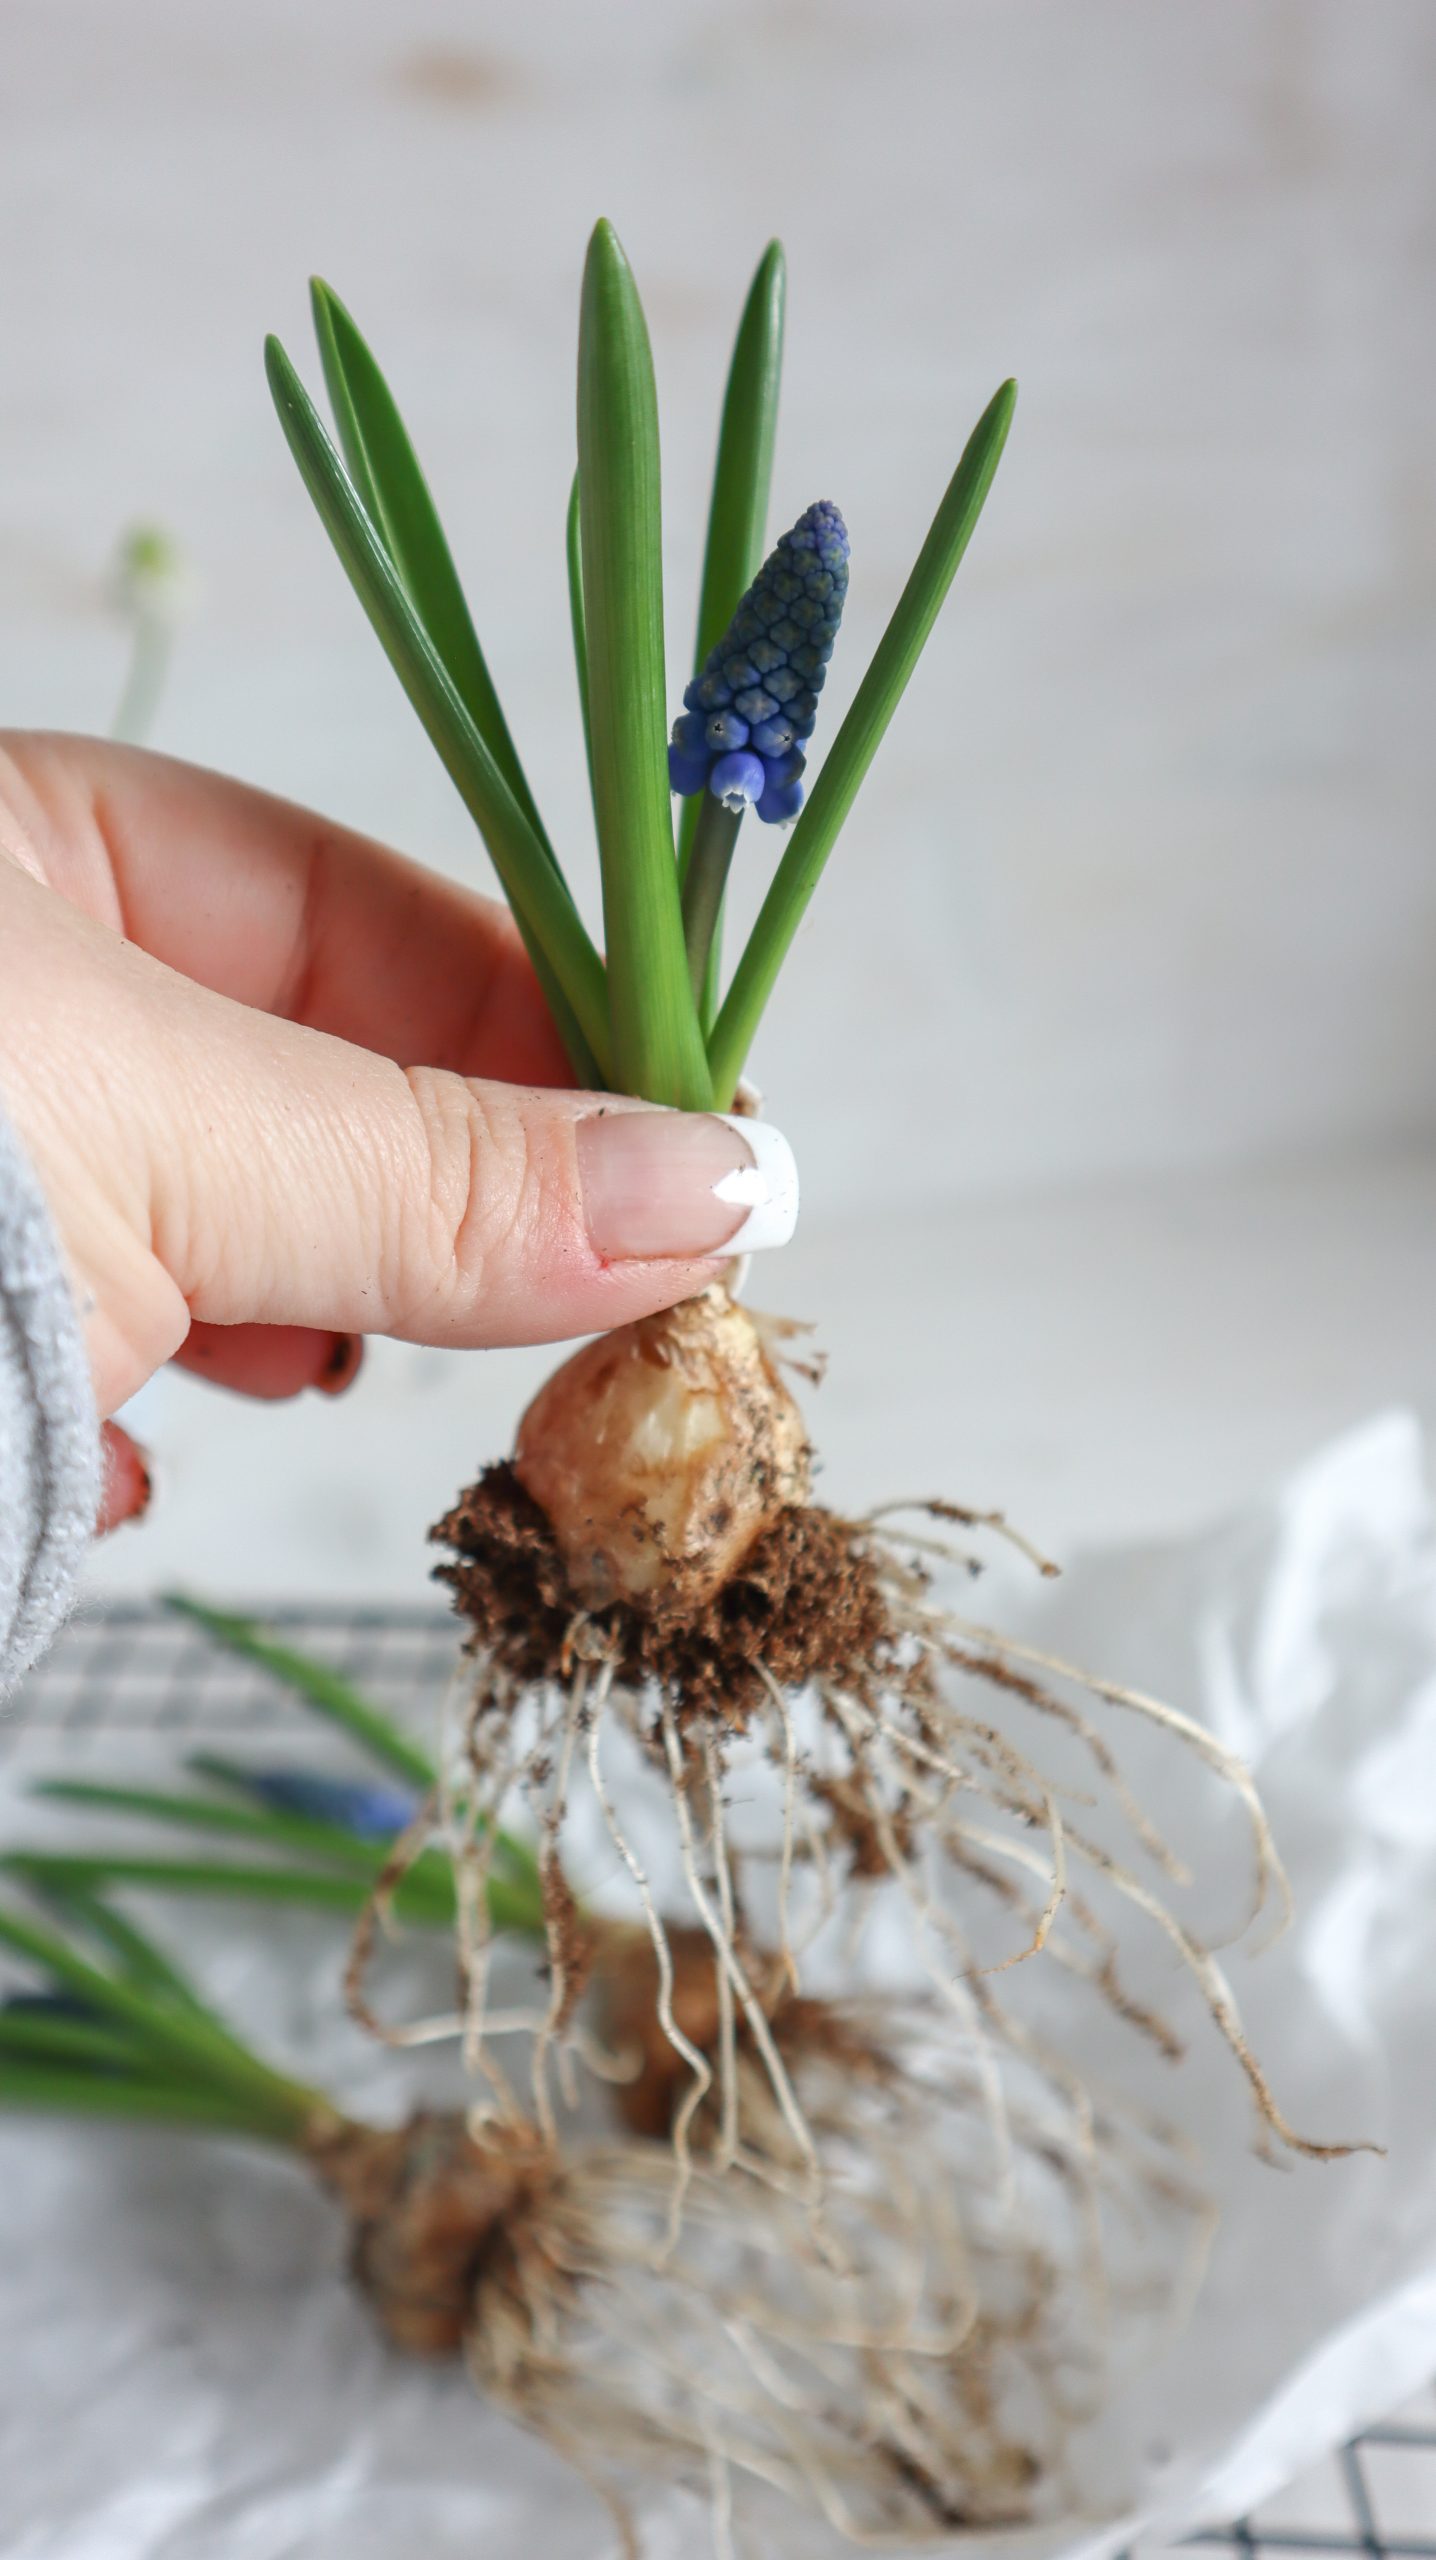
0 1879 1131 2529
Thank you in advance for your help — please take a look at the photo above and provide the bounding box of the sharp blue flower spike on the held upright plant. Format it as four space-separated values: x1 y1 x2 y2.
668 497 847 827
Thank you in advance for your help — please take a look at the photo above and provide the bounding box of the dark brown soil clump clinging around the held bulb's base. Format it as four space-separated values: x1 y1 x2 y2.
430 1462 891 1725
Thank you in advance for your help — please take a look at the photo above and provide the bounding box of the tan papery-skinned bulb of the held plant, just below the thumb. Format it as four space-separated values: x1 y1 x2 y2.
515 1288 811 1615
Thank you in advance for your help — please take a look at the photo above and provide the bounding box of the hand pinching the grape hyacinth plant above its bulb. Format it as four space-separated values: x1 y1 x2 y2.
0 735 791 1464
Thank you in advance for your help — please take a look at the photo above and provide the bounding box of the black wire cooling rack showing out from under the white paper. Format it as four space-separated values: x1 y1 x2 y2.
0 1600 1436 2560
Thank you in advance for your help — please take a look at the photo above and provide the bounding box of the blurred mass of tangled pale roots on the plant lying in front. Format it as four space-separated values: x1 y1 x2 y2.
458 2030 1188 2550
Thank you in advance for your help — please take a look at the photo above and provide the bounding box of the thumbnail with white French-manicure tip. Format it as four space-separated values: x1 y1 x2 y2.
578 1111 799 1262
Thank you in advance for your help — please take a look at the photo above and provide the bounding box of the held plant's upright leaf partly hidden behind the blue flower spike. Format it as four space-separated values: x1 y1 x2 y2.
678 241 788 1032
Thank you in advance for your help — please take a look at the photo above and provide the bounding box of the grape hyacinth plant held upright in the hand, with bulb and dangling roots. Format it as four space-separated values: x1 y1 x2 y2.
269 223 1351 2242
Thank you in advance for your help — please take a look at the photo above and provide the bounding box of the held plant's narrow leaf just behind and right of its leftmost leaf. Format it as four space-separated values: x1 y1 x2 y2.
310 276 555 860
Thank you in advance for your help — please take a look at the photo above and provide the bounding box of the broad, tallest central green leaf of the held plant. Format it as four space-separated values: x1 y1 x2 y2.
578 223 712 1111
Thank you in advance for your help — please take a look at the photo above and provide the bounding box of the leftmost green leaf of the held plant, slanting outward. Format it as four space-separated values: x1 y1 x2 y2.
264 338 609 1080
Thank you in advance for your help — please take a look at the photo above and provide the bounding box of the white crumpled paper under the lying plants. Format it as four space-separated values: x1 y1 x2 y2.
0 1416 1436 2560
